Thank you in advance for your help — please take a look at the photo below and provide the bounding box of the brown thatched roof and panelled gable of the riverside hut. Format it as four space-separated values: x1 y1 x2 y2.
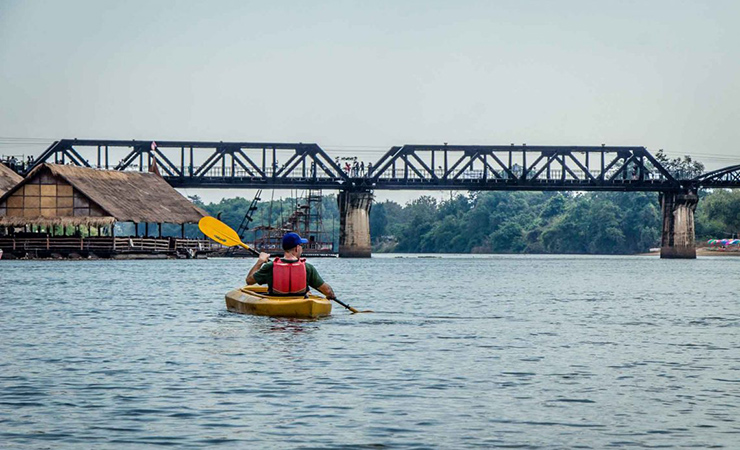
0 164 207 226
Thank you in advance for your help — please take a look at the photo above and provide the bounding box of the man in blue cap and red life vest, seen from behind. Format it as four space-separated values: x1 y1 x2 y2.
247 233 336 299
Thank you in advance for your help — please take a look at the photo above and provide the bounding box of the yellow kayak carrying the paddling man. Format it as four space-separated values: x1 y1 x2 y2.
226 285 331 318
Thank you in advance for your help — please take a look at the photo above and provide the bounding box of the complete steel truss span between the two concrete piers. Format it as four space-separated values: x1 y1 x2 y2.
368 145 680 191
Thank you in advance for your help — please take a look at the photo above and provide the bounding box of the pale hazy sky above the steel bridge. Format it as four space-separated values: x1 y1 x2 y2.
0 0 740 202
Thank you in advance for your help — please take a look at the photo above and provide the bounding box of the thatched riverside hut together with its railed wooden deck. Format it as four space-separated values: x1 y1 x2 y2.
0 164 212 259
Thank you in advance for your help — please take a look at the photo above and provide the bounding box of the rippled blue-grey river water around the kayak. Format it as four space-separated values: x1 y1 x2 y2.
0 255 740 449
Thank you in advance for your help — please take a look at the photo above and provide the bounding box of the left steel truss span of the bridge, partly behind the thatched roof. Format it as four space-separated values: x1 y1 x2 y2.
27 139 348 189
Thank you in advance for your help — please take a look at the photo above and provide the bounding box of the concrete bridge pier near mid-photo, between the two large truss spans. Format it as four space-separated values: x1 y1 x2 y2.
337 191 373 258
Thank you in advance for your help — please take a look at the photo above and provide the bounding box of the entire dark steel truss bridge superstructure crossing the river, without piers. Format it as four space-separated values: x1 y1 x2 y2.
20 139 740 192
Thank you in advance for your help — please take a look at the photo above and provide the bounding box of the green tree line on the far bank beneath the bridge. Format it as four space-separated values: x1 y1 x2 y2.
191 190 740 254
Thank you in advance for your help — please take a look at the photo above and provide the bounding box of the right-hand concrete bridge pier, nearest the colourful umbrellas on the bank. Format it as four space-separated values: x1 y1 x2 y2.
660 191 699 259
